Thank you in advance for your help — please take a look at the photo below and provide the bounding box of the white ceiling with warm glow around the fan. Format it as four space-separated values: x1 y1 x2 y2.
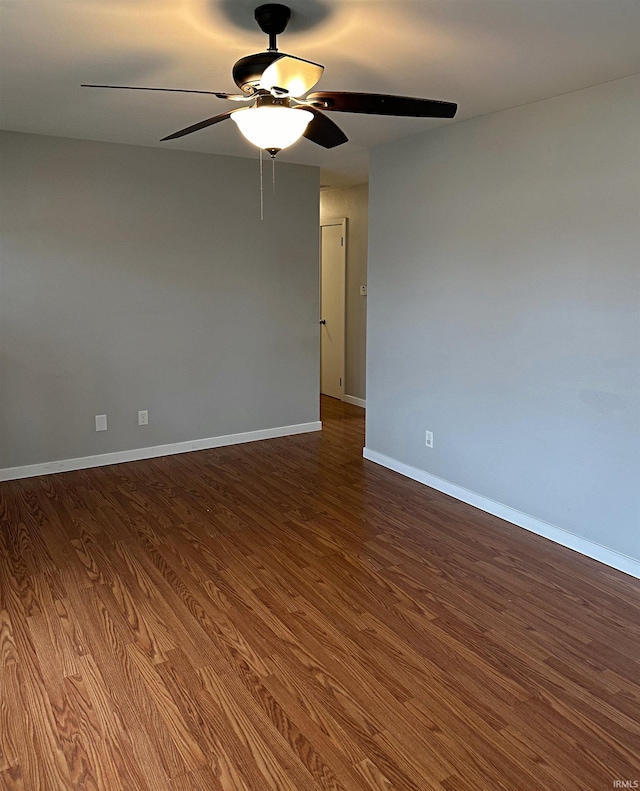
0 0 640 186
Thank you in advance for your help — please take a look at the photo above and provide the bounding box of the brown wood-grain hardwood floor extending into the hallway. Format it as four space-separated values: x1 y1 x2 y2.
0 399 640 791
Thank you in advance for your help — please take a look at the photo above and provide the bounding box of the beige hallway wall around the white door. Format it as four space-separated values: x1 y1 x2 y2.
320 184 369 399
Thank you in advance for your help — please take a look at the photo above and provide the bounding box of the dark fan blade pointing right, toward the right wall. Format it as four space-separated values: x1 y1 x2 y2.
307 91 458 118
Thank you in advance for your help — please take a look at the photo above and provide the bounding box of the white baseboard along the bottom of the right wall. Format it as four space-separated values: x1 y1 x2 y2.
362 448 640 579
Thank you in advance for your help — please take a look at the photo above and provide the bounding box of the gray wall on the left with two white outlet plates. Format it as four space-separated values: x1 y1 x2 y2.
0 132 319 468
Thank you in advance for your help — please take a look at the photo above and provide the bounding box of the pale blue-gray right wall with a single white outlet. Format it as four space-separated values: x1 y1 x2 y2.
367 71 640 558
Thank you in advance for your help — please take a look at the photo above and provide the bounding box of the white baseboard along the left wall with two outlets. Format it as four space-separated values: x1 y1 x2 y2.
0 420 322 481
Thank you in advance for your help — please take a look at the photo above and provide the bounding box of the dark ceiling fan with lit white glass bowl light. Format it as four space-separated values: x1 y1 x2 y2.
82 3 458 157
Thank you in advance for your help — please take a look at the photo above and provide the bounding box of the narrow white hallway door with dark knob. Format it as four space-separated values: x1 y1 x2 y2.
320 219 347 399
